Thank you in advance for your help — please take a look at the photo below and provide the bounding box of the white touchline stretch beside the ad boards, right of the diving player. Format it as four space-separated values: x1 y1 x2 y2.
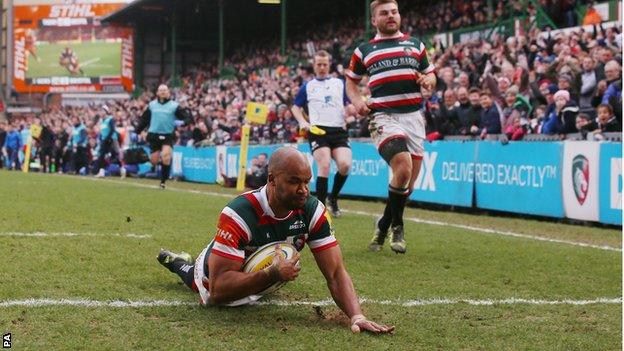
342 210 622 252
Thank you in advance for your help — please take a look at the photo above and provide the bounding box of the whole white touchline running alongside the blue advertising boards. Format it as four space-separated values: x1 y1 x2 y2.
78 177 622 252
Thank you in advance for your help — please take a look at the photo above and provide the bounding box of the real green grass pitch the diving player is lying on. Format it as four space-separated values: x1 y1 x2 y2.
0 171 622 350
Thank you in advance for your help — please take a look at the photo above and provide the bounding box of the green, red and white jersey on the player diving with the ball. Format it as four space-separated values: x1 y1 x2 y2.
208 186 338 262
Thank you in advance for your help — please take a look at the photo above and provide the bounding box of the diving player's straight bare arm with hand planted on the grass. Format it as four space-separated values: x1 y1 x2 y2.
314 246 394 334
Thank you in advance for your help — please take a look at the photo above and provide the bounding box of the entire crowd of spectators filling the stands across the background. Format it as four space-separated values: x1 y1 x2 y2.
0 0 622 175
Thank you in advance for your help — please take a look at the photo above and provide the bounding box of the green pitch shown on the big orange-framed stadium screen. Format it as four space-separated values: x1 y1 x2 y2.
26 42 121 78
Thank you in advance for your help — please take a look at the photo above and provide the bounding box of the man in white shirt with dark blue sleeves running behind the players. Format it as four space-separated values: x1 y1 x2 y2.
292 50 352 217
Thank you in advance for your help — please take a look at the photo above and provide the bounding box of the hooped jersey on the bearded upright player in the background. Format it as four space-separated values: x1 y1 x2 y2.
346 32 435 113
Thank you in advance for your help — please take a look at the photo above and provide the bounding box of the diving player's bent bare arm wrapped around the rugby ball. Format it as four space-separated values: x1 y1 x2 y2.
208 253 301 305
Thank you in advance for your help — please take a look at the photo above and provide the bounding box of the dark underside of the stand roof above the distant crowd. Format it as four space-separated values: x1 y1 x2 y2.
102 0 367 46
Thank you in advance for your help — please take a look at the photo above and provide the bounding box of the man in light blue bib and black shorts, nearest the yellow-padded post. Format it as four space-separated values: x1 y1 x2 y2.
136 84 191 189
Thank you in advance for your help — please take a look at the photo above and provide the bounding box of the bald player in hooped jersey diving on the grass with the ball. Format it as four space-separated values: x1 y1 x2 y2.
158 146 394 333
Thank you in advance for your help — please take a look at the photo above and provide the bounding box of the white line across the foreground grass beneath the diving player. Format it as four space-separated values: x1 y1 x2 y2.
0 297 622 308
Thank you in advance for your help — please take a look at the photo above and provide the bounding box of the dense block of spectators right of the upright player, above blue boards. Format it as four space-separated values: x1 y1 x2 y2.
425 20 622 140
